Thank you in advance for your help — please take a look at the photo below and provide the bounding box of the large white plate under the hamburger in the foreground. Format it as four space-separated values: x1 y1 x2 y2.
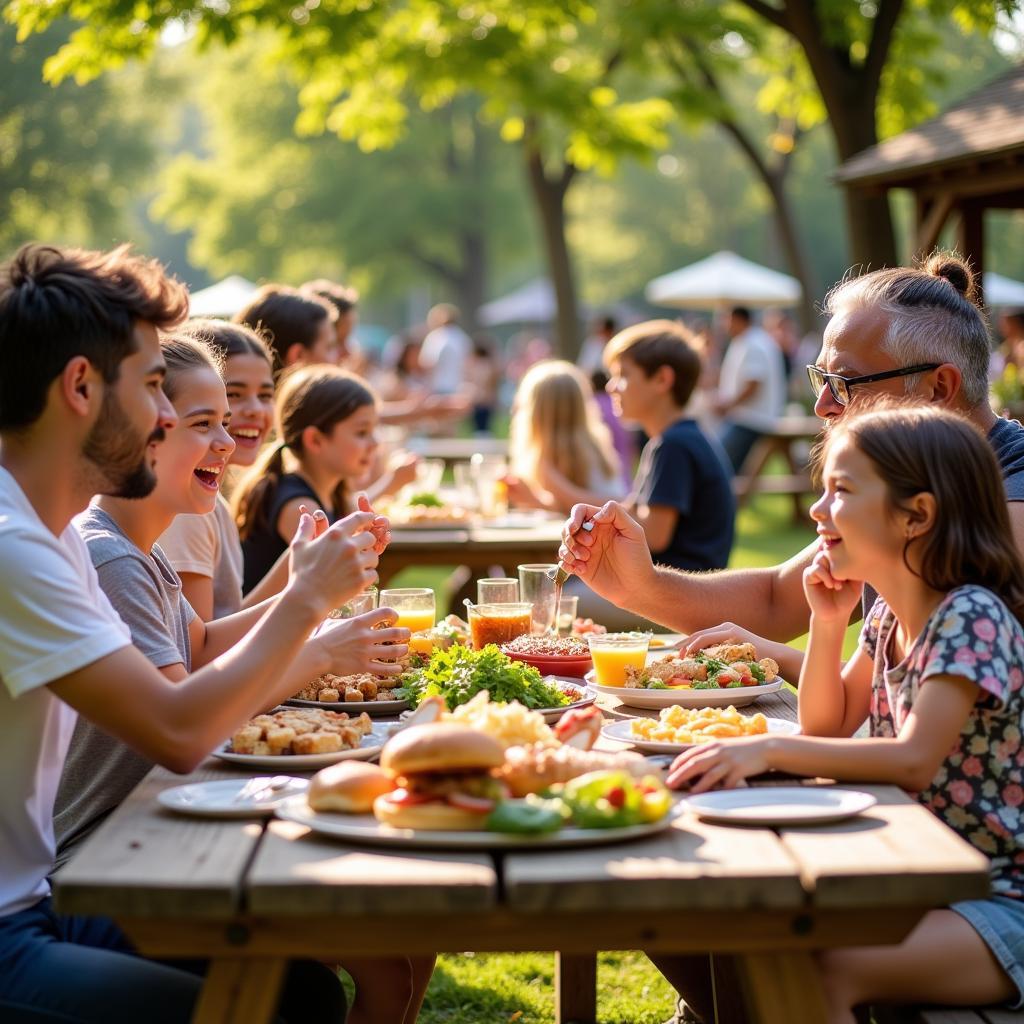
276 797 681 850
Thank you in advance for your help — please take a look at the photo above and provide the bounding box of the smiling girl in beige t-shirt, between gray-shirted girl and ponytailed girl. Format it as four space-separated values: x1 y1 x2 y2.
154 319 280 622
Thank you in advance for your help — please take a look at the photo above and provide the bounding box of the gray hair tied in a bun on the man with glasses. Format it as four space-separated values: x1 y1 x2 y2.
824 252 990 409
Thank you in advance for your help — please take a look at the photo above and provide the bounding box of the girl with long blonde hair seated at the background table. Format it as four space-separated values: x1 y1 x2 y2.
507 359 626 514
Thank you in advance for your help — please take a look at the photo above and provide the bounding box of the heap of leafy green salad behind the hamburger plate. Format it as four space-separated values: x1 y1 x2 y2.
395 644 570 711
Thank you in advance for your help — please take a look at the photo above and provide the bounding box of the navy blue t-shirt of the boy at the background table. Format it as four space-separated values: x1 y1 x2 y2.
633 419 736 569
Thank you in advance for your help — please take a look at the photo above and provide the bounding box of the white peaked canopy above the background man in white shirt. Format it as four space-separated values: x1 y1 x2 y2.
644 251 801 309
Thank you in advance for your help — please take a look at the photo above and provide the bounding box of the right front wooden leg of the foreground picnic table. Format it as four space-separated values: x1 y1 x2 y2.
737 952 828 1024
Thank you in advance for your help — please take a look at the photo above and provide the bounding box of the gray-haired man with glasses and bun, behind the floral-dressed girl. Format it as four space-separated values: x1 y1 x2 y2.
559 253 1024 1021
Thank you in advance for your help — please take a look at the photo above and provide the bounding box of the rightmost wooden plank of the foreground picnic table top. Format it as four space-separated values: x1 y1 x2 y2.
779 783 988 907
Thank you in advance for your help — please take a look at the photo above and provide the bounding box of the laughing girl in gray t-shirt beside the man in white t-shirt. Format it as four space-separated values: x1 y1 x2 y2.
53 334 433 1024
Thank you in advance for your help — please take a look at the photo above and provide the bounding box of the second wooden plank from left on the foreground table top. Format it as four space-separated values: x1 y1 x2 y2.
246 821 498 918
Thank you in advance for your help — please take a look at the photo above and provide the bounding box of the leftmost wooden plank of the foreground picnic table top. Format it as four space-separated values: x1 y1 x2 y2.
53 760 263 919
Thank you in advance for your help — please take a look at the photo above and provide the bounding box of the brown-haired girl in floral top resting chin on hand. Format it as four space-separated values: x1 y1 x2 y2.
659 407 1024 1024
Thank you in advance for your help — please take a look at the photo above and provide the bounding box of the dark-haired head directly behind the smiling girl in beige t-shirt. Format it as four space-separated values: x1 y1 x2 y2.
231 285 338 374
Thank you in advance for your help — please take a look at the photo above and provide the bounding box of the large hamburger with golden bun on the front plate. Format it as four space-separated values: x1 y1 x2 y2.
374 722 508 831
